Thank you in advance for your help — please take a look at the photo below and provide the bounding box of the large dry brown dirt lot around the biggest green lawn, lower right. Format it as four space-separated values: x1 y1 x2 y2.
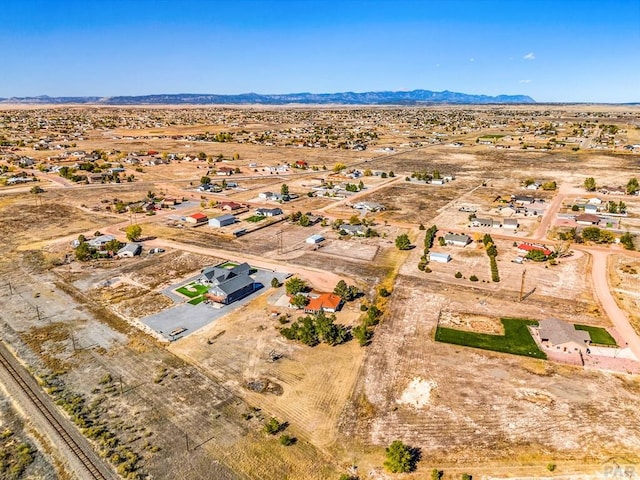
342 277 640 478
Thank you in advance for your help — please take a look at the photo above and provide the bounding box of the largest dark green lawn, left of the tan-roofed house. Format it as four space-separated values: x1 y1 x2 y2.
436 318 547 358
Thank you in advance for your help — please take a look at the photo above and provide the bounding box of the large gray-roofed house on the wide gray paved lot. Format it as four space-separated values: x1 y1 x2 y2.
199 263 260 304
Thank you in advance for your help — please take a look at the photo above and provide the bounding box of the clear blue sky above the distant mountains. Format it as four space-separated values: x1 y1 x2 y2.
0 0 640 102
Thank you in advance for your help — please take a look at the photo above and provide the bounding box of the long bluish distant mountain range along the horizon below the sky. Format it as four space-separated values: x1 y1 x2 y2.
0 90 536 105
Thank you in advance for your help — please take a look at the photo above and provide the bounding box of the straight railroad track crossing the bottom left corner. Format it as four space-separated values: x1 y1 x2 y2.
0 346 113 480
